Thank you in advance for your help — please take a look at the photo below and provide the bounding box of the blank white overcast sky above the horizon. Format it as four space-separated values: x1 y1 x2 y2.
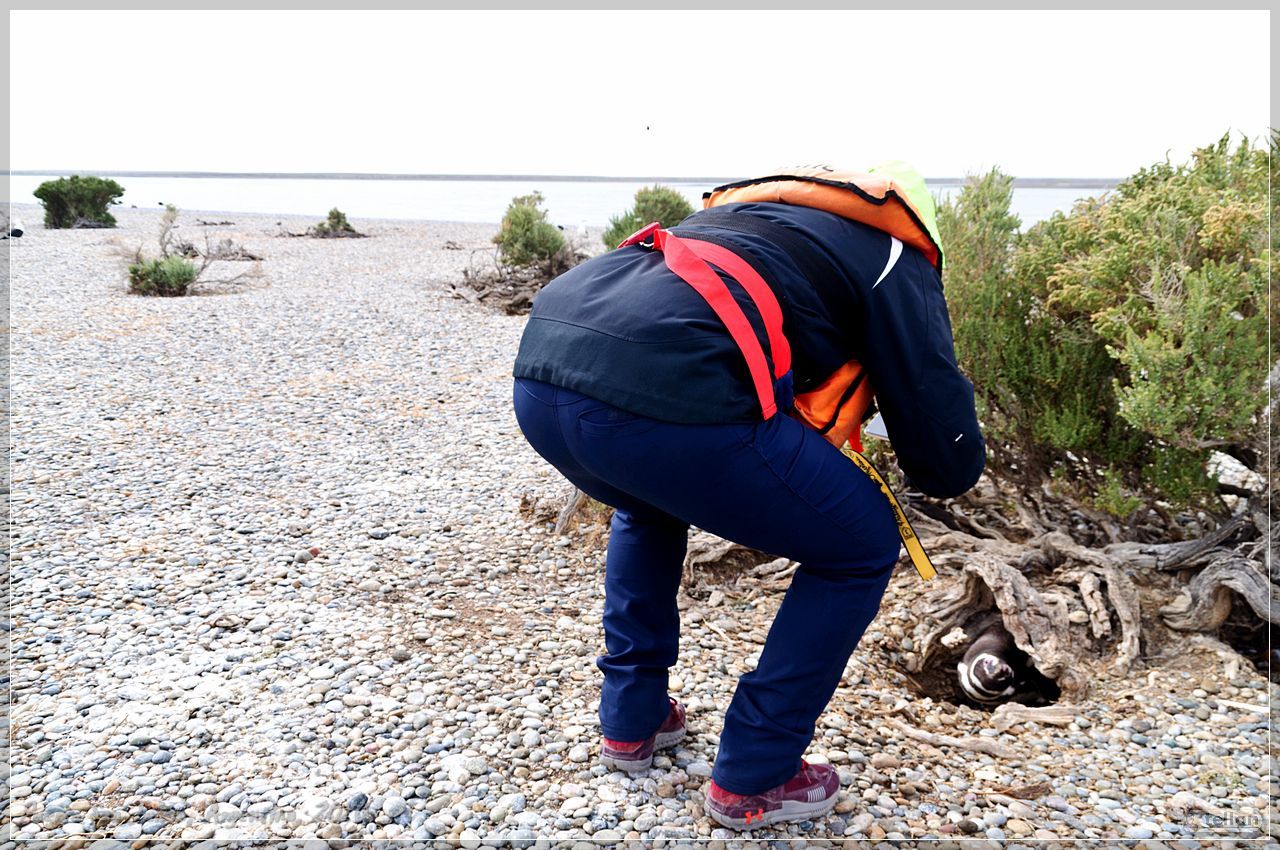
10 12 1270 177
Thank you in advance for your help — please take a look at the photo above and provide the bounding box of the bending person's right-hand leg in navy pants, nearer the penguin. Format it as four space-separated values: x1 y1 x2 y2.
562 408 899 794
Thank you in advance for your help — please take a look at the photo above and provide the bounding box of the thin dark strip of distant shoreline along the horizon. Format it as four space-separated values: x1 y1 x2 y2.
9 169 1120 189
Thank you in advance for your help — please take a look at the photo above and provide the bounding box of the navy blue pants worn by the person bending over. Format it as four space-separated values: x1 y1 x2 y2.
515 379 900 794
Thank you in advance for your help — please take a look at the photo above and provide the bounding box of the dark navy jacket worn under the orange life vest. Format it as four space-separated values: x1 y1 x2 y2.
515 204 986 498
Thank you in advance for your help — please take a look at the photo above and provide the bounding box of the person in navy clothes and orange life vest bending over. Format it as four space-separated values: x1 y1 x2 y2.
513 164 986 828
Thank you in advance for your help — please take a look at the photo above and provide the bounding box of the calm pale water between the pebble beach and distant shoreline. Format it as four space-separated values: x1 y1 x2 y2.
10 174 1105 228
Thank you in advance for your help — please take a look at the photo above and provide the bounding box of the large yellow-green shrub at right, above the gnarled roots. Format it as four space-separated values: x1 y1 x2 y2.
938 131 1274 511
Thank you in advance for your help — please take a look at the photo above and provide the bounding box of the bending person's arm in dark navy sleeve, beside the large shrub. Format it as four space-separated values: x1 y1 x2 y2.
860 246 987 498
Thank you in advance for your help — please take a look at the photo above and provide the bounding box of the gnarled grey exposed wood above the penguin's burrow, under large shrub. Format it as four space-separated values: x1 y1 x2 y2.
906 468 1280 700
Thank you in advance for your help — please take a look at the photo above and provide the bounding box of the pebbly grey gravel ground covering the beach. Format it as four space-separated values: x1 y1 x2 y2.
3 207 1280 850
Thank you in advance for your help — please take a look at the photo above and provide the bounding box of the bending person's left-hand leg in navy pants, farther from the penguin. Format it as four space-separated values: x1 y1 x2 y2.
515 380 689 741
